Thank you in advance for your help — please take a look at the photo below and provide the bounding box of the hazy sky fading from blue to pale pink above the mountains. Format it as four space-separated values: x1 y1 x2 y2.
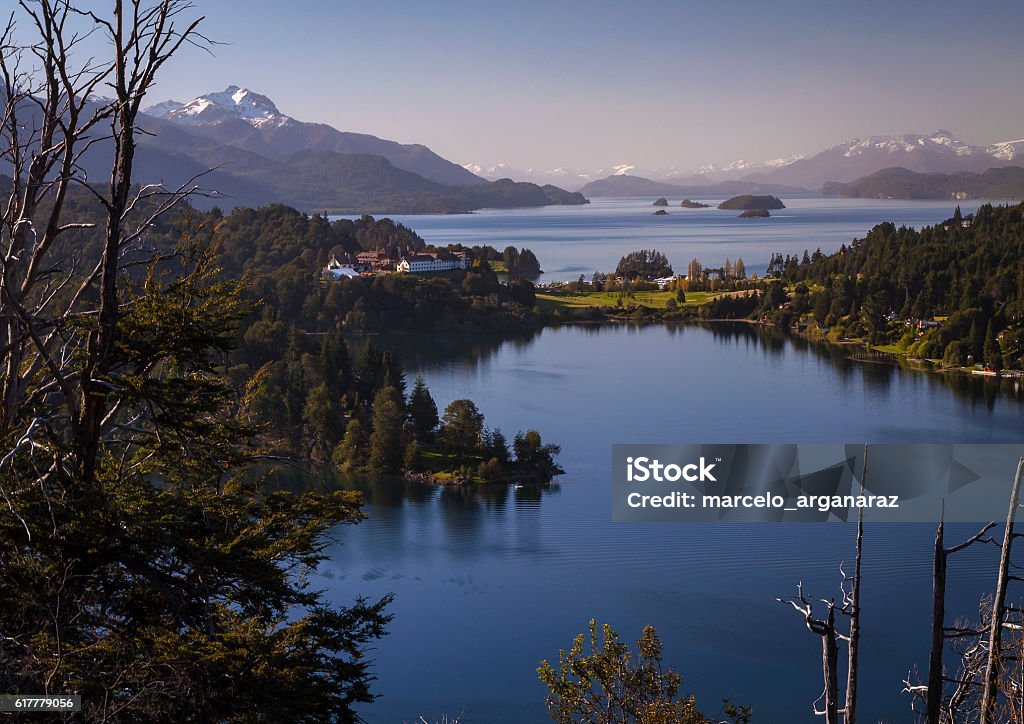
123 0 1024 169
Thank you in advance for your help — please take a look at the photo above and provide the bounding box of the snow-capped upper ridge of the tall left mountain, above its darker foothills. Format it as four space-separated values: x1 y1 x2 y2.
144 85 483 185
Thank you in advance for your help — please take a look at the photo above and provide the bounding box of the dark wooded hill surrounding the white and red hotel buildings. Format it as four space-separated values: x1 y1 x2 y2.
195 205 536 333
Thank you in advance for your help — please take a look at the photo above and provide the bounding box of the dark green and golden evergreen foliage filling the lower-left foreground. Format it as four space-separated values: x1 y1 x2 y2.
0 235 388 721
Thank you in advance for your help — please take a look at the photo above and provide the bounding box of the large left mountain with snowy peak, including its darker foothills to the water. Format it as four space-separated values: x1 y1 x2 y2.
24 86 587 214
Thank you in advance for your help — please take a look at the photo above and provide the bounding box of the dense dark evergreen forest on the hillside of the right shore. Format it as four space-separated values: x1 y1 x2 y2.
761 205 1024 369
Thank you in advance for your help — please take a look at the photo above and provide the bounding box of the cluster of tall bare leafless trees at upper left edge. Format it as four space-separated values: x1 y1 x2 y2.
0 0 206 483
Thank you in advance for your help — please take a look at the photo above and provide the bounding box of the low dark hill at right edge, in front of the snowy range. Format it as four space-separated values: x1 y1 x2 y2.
821 166 1024 199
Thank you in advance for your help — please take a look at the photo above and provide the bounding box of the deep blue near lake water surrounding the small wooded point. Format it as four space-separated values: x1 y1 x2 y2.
317 325 1024 723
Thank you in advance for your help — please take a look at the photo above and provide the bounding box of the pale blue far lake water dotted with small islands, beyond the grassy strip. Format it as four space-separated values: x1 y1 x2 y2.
331 197 1006 281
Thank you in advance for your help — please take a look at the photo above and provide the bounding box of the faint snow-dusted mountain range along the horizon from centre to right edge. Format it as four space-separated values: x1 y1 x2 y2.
466 130 1024 196
